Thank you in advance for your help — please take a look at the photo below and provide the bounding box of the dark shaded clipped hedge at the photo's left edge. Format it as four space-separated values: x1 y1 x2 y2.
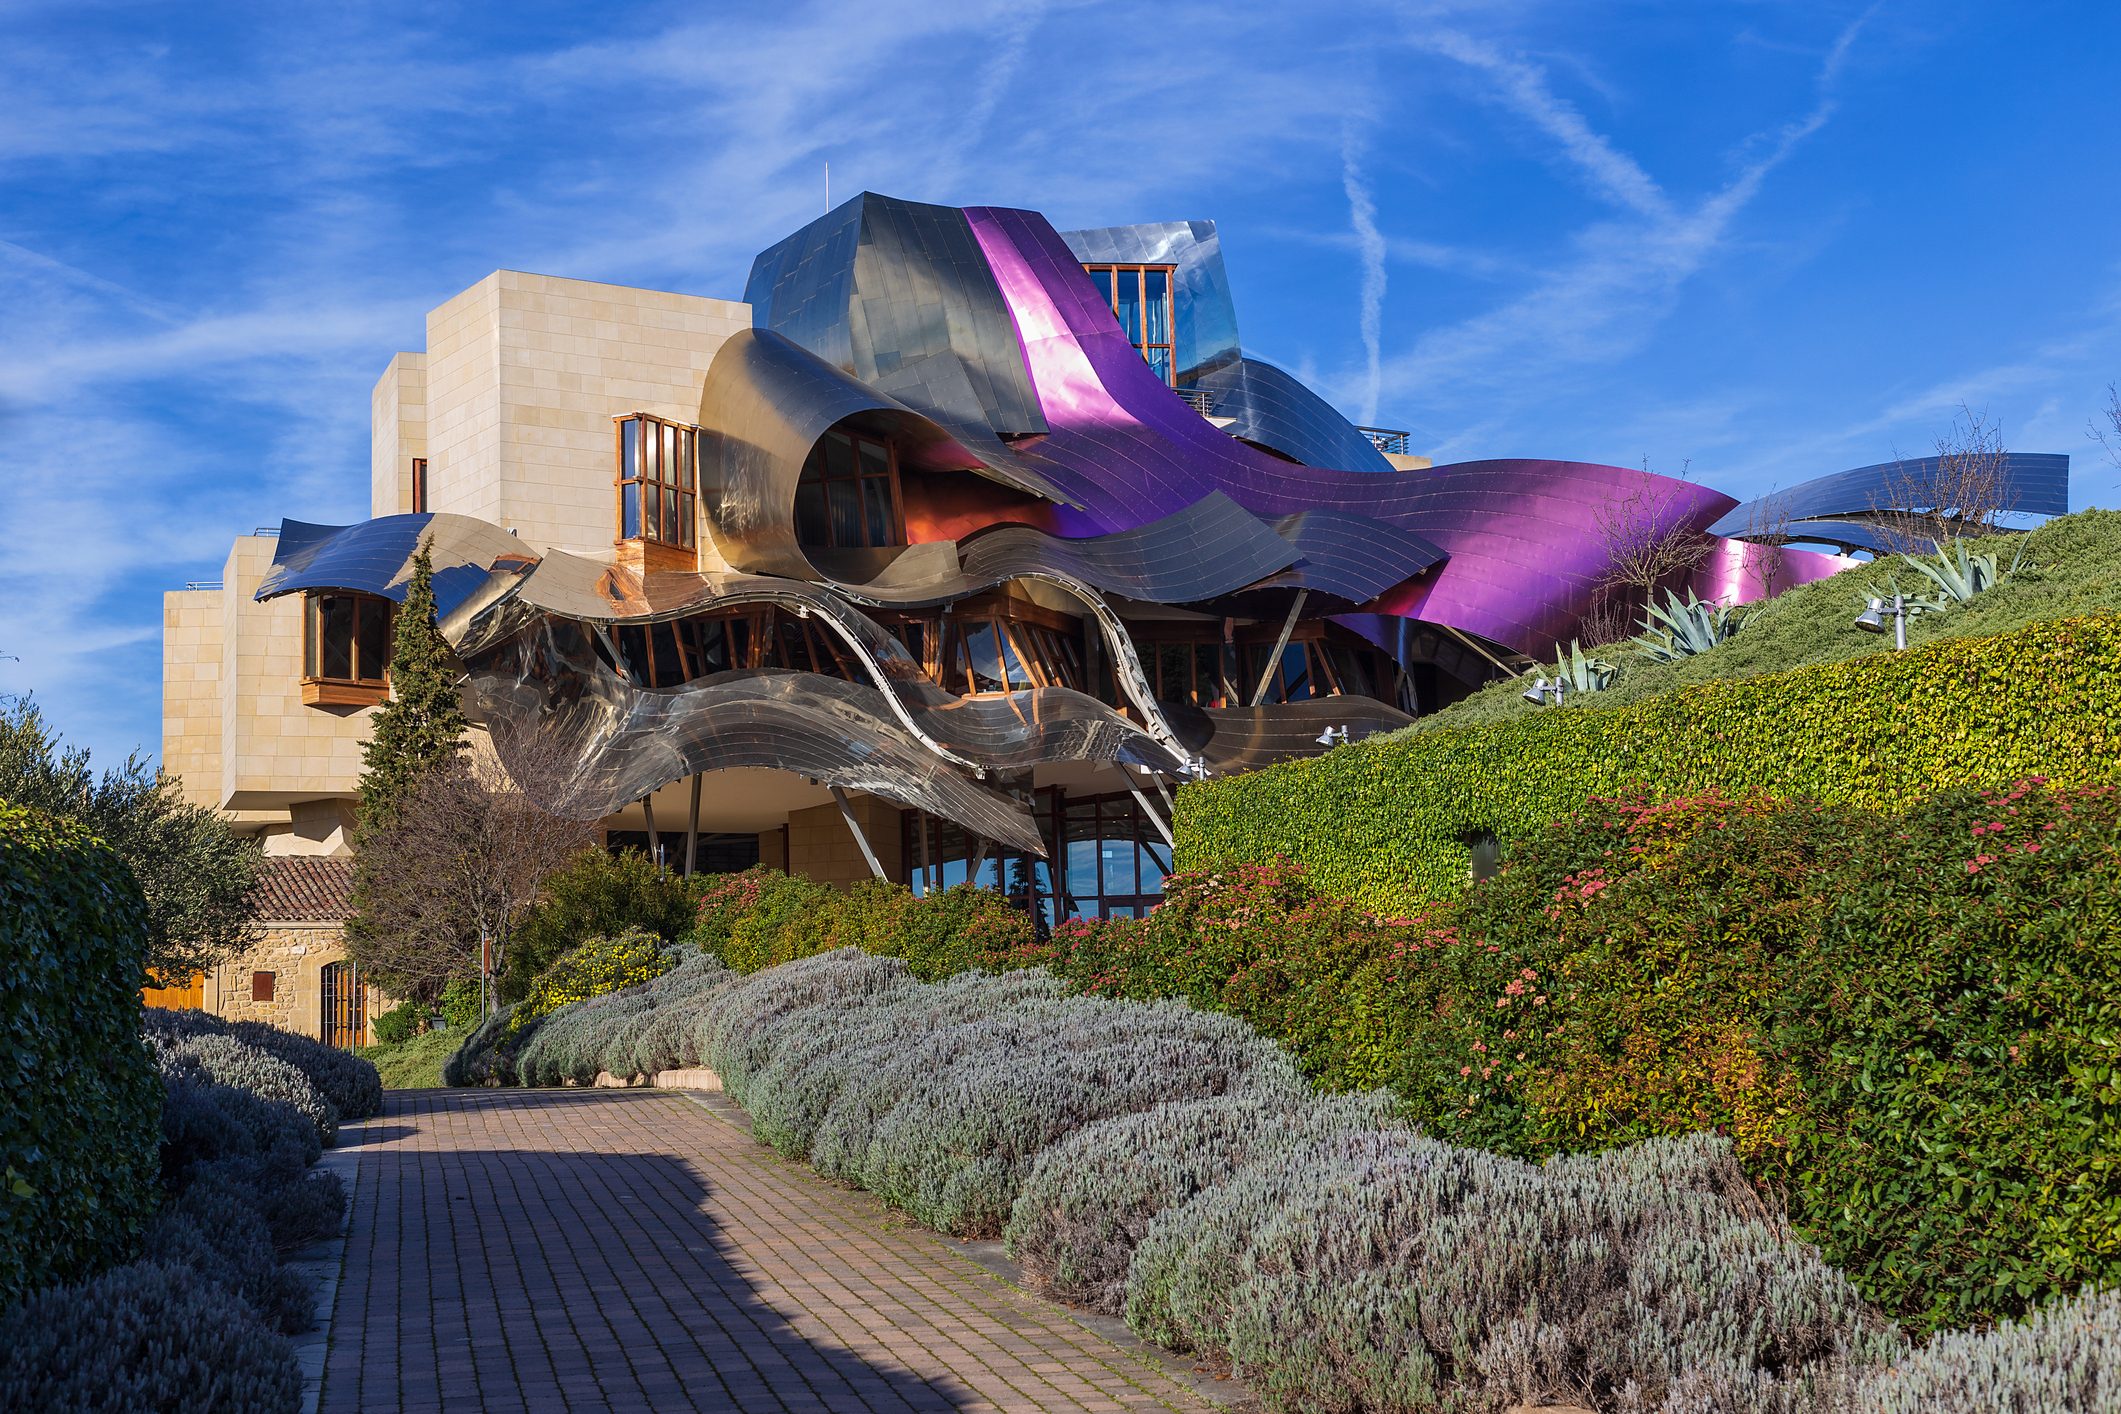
0 803 161 1308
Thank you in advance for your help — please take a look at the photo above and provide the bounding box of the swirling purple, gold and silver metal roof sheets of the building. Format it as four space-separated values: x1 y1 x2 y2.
243 193 1968 852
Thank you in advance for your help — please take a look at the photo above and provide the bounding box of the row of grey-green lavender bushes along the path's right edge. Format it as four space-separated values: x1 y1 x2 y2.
485 952 2121 1414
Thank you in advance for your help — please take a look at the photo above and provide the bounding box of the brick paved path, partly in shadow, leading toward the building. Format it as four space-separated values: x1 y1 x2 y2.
322 1090 1238 1414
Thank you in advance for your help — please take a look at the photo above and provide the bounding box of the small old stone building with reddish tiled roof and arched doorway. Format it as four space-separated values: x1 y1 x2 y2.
195 856 388 1045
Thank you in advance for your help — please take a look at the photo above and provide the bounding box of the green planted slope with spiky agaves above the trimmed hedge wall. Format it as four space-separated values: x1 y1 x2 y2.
1404 511 2121 733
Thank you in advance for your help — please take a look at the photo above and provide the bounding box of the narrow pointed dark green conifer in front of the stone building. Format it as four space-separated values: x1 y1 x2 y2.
361 541 464 833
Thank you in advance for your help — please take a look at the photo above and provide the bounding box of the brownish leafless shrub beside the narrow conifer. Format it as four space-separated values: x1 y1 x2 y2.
348 725 598 1001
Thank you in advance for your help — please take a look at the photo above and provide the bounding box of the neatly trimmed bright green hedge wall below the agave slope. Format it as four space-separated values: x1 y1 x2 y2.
1177 615 2121 912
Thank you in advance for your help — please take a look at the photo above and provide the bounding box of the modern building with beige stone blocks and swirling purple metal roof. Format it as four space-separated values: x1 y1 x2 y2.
163 193 2066 941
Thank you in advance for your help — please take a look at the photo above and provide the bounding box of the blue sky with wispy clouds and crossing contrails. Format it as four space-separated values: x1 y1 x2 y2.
0 0 2121 775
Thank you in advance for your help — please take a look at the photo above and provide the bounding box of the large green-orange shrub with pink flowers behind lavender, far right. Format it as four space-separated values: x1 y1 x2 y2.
1396 780 2121 1327
